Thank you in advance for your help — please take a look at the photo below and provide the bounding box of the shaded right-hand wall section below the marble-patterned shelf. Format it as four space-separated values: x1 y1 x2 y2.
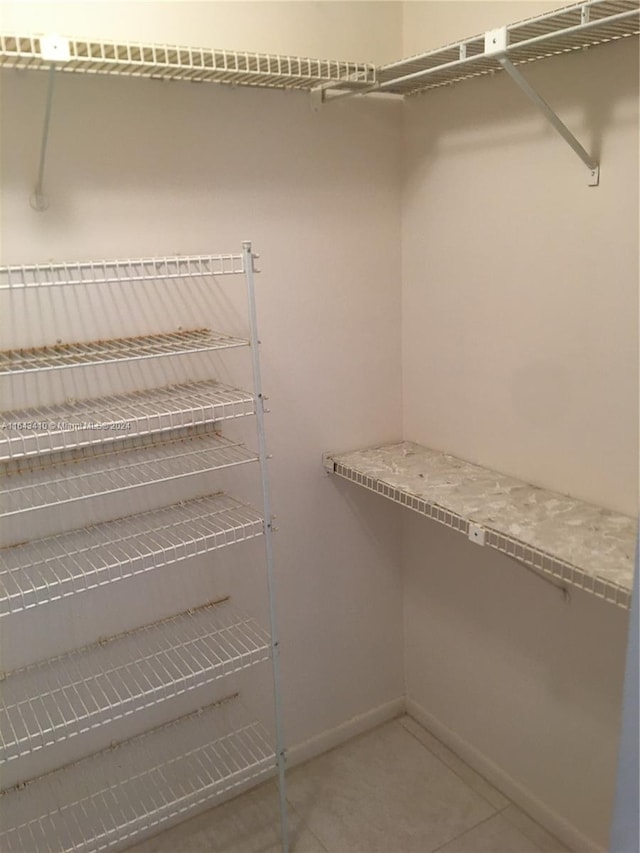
403 513 628 853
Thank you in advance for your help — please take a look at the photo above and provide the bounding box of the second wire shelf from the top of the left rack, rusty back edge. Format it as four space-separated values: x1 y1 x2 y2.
0 329 248 374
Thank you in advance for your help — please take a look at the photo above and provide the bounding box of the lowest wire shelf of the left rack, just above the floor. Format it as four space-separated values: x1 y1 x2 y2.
0 702 275 853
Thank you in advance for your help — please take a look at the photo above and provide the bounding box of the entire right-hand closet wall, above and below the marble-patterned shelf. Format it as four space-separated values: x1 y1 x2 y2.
403 3 638 850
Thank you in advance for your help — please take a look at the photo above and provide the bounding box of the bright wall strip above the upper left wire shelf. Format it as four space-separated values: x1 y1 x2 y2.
0 0 402 63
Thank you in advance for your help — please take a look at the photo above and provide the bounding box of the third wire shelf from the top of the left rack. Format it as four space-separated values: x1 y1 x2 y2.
0 381 255 462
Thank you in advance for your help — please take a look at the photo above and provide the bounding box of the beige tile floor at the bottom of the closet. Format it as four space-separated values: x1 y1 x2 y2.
129 716 567 853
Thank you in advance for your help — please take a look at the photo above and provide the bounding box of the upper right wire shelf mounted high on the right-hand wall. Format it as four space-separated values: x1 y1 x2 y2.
377 0 640 95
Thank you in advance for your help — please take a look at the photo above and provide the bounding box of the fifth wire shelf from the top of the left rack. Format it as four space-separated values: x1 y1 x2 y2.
0 494 264 617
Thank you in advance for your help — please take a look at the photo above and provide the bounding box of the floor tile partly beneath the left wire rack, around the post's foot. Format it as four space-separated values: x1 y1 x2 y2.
128 782 326 853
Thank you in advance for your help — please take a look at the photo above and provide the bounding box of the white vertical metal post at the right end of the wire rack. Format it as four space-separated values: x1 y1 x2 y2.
242 241 289 853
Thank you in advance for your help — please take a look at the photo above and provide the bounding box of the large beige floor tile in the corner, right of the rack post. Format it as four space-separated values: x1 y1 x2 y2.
288 721 495 853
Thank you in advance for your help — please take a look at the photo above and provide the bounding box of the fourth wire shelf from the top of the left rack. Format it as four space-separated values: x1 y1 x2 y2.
3 433 257 518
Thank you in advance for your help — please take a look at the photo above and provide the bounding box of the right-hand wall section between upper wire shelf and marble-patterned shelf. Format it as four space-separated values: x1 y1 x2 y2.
403 41 638 515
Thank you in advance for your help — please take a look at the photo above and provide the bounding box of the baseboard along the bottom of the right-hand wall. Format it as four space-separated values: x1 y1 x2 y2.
405 699 606 853
